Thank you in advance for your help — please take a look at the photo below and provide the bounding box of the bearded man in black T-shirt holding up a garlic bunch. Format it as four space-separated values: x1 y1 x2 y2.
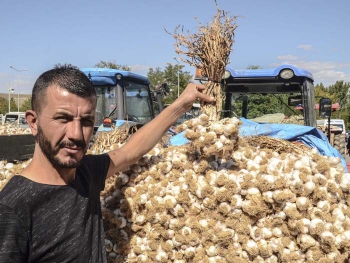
0 66 213 263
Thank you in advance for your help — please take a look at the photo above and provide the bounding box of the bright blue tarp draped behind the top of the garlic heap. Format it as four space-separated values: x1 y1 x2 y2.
170 118 348 172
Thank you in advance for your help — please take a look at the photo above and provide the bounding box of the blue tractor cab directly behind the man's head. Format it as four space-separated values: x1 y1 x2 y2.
80 68 165 131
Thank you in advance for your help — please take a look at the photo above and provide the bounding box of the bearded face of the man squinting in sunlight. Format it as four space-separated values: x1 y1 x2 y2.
36 86 96 168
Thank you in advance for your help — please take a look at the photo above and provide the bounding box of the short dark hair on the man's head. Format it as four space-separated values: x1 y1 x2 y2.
32 64 96 112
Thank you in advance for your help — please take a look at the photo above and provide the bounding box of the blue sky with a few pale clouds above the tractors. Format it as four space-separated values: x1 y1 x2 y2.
0 0 350 94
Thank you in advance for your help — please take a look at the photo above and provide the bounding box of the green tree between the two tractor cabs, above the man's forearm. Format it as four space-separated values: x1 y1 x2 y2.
147 63 192 104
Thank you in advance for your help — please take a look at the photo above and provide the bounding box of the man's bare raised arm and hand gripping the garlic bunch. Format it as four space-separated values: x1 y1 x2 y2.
107 83 214 177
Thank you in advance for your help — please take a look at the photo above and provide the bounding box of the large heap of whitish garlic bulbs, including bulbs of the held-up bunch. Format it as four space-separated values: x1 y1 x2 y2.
101 115 350 263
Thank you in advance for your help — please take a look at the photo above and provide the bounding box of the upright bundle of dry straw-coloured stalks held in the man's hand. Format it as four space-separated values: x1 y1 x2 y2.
171 1 237 121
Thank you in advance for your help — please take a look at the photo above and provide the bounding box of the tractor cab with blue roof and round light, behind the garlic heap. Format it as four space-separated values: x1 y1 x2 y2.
217 65 316 127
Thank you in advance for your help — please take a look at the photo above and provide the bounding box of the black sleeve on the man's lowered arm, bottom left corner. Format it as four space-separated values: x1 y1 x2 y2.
0 204 29 263
